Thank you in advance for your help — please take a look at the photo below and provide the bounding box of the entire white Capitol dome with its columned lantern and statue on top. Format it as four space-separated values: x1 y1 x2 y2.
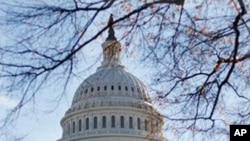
58 15 164 141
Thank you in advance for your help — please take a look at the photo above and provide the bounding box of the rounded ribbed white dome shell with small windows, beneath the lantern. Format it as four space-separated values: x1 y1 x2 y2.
72 68 150 105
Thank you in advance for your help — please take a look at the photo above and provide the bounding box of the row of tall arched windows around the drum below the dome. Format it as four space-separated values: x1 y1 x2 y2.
64 115 156 135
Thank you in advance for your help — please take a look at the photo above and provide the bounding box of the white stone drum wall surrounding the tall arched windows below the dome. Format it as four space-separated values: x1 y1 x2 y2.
60 107 163 141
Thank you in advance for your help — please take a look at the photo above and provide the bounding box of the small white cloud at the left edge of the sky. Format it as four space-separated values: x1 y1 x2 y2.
0 95 17 109
